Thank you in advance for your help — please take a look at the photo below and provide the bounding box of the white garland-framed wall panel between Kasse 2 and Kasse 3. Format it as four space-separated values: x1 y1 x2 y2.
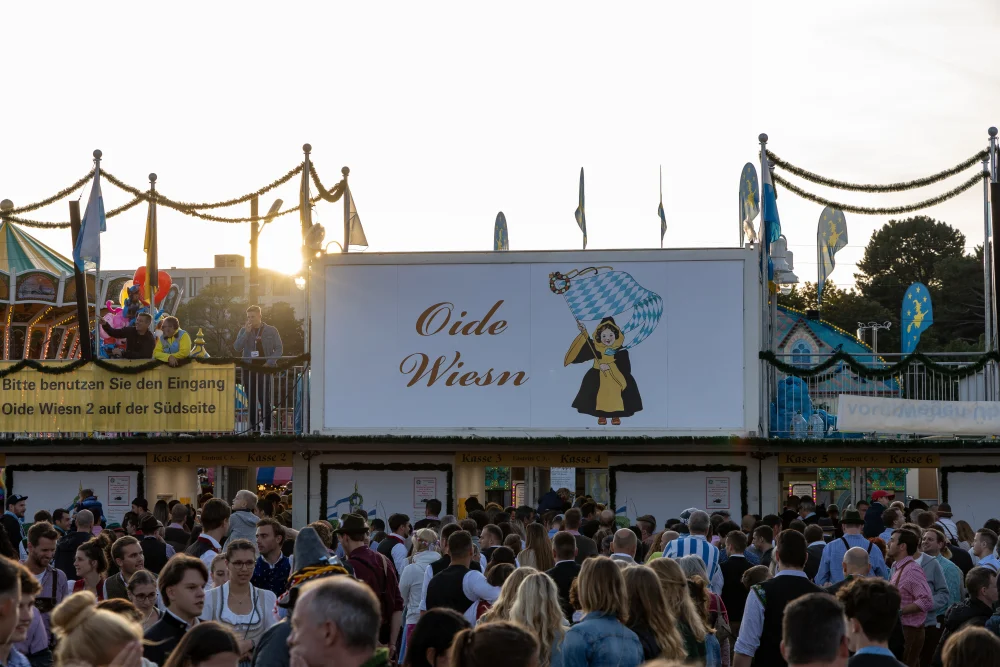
321 468 448 524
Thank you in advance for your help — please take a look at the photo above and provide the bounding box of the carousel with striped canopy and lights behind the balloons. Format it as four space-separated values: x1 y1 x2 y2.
0 220 181 361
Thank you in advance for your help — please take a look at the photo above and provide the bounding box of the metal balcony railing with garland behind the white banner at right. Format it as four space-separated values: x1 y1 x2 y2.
761 352 1000 438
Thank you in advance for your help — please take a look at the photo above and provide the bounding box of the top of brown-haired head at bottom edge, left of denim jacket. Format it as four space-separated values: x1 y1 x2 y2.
451 622 540 667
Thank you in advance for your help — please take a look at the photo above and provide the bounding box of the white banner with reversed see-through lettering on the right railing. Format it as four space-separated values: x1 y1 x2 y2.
837 394 1000 435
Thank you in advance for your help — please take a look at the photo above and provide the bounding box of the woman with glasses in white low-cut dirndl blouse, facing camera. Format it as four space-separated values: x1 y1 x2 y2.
201 539 277 667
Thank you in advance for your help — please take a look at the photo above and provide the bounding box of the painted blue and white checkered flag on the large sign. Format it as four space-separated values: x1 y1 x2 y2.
550 269 663 350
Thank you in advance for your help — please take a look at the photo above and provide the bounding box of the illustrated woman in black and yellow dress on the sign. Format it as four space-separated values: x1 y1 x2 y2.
563 317 642 426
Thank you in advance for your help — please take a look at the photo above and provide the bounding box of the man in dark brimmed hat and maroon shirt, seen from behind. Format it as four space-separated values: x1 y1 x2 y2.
336 514 403 658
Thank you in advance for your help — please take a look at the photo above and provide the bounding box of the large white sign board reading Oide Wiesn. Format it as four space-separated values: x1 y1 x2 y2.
314 250 757 435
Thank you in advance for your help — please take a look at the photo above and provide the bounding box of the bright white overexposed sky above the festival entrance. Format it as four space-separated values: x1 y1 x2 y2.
0 0 1000 285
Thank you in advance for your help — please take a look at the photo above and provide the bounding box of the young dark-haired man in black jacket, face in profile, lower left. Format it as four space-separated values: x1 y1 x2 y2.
143 552 211 665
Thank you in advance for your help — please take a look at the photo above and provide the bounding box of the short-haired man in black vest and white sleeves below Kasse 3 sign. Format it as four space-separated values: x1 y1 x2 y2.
427 530 500 624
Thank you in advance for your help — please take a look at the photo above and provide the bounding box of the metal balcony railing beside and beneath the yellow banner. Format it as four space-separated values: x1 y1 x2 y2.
0 357 309 441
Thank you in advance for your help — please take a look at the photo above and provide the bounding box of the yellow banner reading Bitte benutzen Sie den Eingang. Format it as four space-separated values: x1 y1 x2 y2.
0 361 236 433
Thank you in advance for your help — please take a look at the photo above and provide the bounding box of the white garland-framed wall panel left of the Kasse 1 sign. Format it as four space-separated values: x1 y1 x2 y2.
10 466 139 523
